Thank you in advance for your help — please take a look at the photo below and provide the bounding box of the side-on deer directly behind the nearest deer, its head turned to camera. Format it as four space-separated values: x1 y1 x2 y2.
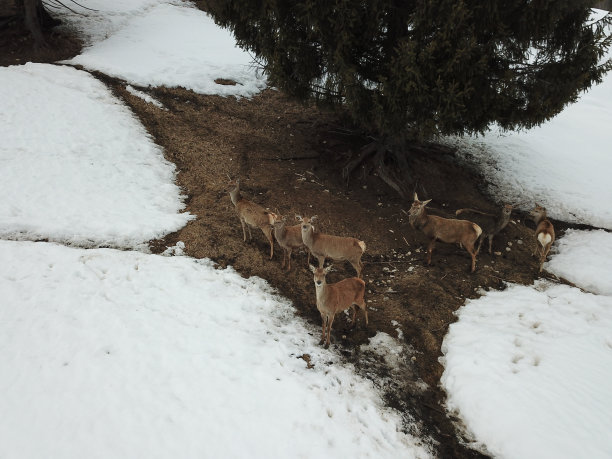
296 215 366 278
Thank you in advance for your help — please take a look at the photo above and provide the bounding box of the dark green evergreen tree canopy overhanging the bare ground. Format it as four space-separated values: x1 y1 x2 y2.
204 0 612 138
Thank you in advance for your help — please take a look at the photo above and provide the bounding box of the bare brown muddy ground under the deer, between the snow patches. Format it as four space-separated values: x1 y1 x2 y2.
0 19 580 458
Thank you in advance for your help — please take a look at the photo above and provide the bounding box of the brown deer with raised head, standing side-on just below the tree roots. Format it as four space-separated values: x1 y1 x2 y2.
408 193 482 272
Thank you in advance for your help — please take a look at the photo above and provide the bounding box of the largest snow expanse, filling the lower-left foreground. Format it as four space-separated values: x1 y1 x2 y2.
0 241 429 458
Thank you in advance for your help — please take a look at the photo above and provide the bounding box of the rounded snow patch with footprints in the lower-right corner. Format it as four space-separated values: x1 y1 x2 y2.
441 281 612 459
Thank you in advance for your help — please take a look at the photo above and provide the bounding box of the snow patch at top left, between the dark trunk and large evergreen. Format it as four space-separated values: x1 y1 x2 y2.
63 0 266 97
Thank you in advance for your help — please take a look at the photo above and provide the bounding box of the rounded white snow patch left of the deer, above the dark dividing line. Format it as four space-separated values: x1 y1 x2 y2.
0 63 192 247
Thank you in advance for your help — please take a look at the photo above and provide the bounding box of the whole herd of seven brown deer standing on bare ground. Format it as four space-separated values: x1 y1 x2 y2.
228 179 555 348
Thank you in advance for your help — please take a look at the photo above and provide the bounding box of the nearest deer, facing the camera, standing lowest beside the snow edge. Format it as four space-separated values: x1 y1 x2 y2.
309 265 368 349
